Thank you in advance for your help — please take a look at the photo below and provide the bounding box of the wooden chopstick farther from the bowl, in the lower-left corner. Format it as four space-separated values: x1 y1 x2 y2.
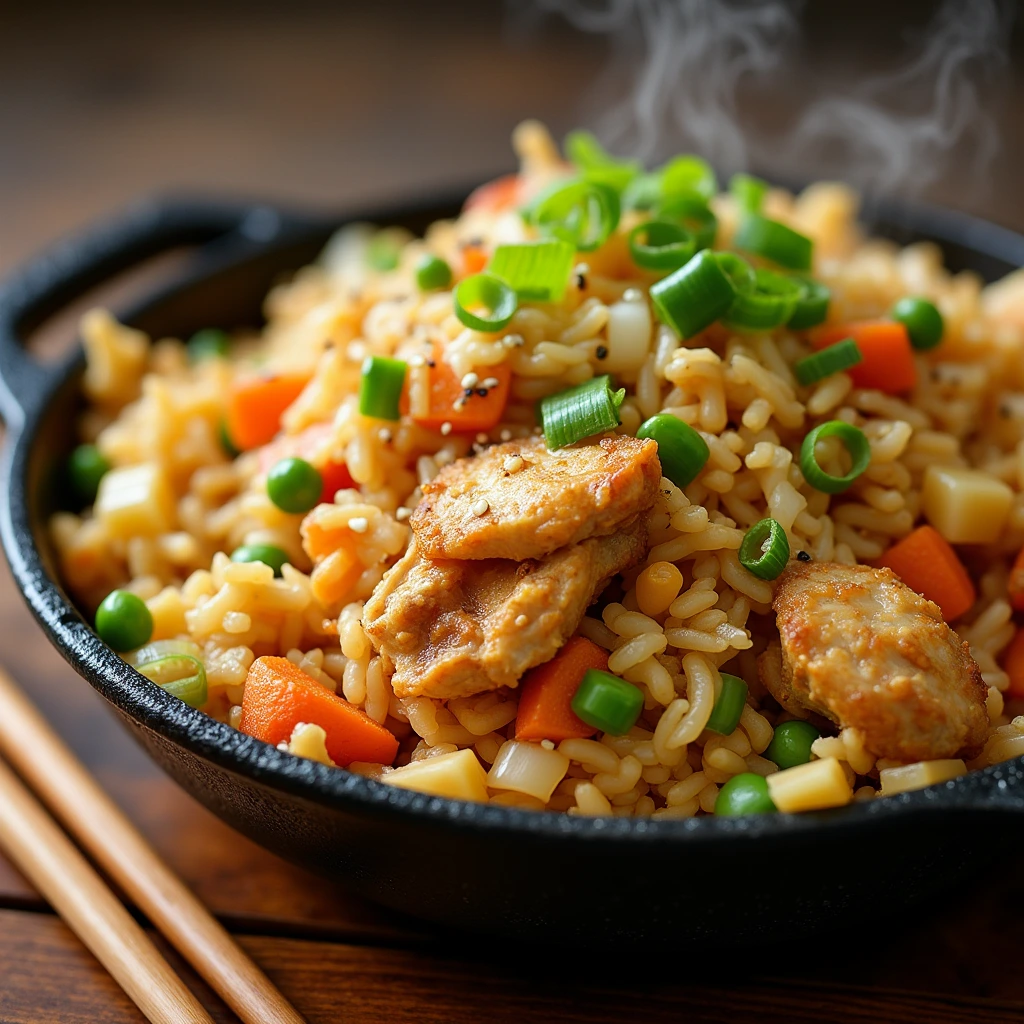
0 761 213 1024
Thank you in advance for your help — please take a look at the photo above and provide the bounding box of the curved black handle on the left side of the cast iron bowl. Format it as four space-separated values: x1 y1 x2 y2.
0 199 272 433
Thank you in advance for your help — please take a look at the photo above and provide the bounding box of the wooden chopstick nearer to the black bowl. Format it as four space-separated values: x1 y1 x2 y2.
0 669 305 1024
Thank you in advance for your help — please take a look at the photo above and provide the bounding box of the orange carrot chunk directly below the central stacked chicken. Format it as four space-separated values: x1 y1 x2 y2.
515 637 608 742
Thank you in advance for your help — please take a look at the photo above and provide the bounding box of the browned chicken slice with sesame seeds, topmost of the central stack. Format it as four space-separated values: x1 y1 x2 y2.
410 437 662 561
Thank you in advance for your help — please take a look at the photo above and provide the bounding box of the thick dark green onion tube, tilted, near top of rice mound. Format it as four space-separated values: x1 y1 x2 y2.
650 249 753 339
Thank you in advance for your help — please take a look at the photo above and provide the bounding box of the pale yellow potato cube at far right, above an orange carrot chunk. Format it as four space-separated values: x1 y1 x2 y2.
922 466 1014 544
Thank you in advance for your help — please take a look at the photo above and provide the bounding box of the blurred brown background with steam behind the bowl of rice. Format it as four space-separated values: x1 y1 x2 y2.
0 0 1024 273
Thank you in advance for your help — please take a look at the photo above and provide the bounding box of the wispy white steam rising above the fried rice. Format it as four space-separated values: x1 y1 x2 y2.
520 0 1013 194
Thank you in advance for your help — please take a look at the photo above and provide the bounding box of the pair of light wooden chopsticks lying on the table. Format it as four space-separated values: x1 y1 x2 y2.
0 670 304 1024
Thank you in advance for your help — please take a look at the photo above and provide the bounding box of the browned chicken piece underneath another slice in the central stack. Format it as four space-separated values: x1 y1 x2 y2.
362 521 647 697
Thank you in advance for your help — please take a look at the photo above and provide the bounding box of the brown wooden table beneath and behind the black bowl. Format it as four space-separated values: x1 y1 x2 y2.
6 0 1024 1024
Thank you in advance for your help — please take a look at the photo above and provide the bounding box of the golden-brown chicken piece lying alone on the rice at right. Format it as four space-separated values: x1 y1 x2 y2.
759 562 988 761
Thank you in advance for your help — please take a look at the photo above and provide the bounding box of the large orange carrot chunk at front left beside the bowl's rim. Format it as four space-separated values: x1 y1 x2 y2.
239 657 398 767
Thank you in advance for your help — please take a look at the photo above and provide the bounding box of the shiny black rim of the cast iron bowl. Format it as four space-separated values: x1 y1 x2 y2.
6 191 1024 848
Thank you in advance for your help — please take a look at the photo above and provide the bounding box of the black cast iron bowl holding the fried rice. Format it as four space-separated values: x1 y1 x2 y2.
6 197 1024 947
